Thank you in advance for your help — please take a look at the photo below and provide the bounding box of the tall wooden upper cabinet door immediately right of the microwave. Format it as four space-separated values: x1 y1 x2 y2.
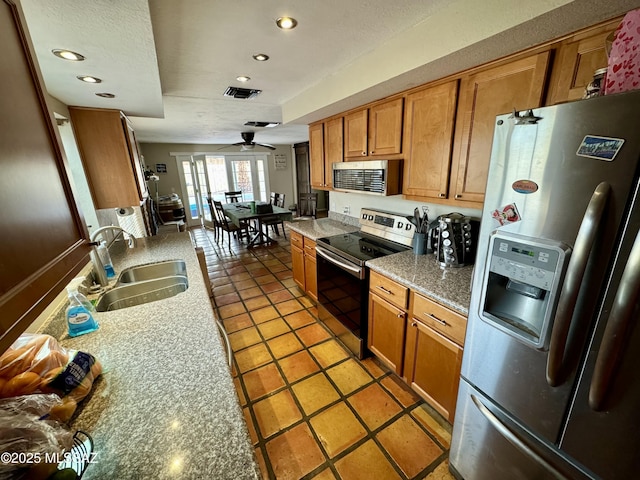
403 80 458 199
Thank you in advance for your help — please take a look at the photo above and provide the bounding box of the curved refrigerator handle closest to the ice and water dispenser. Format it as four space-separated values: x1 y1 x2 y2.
547 182 611 387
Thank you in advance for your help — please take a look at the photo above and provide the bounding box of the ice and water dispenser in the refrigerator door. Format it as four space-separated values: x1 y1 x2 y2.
480 231 571 348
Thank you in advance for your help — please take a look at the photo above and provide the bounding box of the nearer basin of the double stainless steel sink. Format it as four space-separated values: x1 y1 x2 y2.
96 275 189 312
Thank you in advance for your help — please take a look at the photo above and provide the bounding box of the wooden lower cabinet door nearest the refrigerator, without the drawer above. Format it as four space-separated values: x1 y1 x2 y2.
404 318 462 423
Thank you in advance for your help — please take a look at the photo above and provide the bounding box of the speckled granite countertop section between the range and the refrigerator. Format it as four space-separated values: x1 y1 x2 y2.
366 251 473 316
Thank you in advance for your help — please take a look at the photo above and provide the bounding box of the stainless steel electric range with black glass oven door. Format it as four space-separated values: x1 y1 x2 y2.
316 208 416 358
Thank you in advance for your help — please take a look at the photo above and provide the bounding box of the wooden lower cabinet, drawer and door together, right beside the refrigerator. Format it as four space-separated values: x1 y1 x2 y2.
403 292 466 423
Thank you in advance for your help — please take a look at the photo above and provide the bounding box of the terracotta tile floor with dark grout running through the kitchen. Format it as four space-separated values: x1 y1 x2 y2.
190 229 453 480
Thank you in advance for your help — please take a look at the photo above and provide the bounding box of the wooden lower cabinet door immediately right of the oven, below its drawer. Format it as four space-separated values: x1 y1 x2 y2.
367 293 407 375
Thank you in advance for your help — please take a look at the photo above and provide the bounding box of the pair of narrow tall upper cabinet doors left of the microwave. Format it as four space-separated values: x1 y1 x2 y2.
309 117 343 190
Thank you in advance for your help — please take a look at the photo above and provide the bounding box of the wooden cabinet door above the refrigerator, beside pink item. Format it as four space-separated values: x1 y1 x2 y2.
545 17 622 105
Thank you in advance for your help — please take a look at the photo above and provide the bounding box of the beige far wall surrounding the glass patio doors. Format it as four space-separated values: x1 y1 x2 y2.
140 143 295 206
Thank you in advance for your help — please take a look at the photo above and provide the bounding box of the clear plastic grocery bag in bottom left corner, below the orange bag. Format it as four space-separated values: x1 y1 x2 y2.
0 394 73 479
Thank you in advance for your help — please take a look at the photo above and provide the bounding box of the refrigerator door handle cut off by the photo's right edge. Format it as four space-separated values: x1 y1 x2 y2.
589 227 640 411
